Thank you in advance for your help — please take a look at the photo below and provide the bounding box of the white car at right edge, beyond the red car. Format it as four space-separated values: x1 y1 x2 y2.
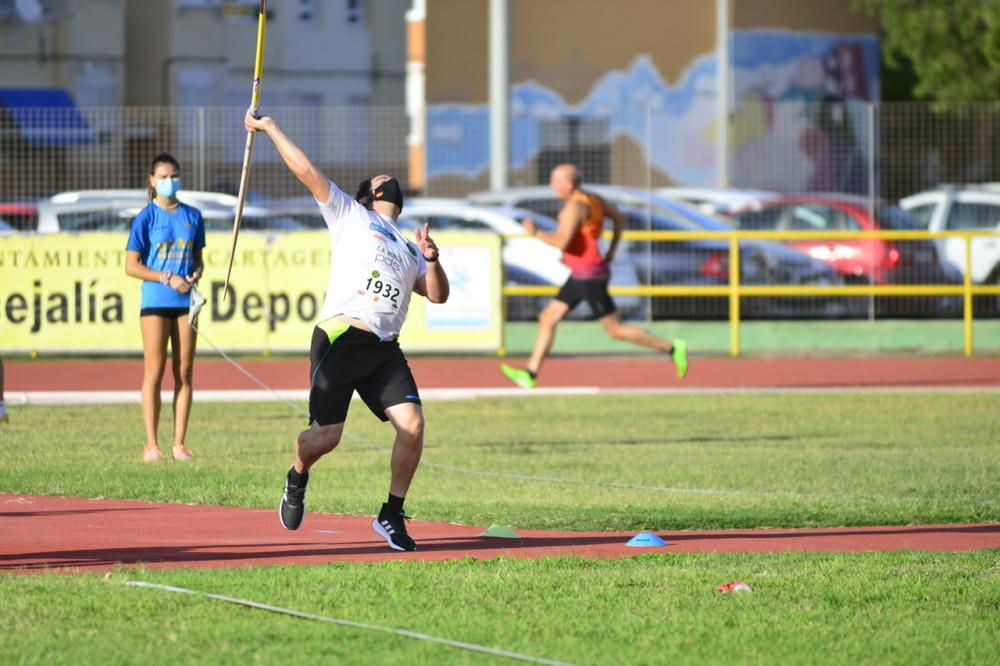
899 184 1000 314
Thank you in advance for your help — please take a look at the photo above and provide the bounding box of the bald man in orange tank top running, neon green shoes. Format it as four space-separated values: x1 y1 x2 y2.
500 164 687 388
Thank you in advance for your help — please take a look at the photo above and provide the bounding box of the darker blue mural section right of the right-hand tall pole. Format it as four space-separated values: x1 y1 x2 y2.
730 30 879 193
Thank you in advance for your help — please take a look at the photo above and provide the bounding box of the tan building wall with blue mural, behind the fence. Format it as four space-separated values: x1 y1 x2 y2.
411 0 879 194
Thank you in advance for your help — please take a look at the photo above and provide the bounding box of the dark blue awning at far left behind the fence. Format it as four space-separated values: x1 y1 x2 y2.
0 88 94 146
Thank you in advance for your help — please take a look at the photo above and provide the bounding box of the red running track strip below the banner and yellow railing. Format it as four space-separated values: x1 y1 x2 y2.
5 356 1000 391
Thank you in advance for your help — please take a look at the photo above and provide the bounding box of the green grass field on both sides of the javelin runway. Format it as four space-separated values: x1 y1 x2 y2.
0 393 1000 664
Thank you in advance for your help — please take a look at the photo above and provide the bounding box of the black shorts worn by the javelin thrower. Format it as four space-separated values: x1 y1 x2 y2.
309 319 420 425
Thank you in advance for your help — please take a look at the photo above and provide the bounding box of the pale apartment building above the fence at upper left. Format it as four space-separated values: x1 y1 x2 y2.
0 0 409 107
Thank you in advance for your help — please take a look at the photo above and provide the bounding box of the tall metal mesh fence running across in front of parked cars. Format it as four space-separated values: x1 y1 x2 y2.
0 99 1000 330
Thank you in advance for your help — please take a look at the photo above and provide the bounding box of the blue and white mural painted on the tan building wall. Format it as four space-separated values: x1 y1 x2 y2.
427 30 878 191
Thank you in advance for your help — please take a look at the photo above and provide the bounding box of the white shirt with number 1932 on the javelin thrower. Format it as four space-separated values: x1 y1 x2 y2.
317 182 427 340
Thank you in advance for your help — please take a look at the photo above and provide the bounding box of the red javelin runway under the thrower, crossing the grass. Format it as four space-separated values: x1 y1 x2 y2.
0 494 1000 573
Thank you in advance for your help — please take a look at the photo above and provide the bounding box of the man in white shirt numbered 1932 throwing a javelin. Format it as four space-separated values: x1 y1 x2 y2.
245 111 448 550
